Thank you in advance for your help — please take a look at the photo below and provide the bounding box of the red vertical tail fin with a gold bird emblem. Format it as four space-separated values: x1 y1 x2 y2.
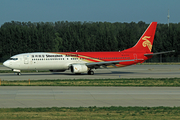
125 22 157 53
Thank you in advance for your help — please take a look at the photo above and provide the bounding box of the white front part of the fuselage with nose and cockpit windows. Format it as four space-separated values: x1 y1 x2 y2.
3 52 86 70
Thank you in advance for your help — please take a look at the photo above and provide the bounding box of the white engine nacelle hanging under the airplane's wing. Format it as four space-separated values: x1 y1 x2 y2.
71 64 88 73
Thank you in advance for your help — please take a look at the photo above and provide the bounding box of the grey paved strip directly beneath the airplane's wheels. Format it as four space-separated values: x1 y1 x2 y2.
0 65 180 80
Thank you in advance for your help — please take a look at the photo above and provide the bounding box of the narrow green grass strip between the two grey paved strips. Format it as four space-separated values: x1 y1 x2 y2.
1 78 180 87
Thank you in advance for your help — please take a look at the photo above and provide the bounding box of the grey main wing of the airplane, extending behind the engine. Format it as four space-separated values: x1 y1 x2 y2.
86 59 135 68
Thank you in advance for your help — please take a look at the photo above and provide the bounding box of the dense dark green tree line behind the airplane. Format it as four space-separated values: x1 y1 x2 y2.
0 21 180 62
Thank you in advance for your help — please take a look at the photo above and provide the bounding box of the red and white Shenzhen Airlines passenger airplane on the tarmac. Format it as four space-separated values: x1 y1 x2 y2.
3 22 174 75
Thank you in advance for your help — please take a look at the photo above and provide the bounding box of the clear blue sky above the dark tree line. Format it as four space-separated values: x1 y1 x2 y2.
0 0 180 25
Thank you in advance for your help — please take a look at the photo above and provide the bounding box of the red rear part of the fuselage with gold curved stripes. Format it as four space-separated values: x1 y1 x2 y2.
50 51 149 67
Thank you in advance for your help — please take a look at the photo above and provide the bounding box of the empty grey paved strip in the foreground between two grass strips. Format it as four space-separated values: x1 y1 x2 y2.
0 86 180 108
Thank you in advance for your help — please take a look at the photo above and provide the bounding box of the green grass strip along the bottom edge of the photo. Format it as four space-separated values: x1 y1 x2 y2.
0 106 180 120
